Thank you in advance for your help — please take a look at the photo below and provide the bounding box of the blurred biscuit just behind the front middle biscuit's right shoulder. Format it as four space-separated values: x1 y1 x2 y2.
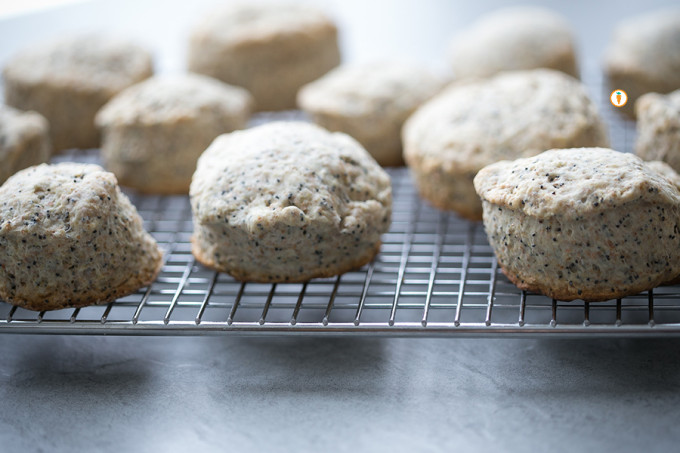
298 63 443 166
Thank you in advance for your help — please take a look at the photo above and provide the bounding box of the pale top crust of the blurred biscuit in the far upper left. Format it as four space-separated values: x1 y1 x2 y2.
4 34 153 94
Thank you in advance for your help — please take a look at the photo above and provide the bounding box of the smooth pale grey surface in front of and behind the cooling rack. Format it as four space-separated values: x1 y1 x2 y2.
0 0 680 452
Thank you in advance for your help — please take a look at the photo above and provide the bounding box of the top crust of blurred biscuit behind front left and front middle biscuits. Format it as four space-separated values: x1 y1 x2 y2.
96 74 253 126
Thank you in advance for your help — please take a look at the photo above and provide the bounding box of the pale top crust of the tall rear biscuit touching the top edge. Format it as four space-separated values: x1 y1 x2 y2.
193 2 336 45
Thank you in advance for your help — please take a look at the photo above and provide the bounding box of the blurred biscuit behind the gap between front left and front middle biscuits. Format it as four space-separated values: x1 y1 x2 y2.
96 75 253 194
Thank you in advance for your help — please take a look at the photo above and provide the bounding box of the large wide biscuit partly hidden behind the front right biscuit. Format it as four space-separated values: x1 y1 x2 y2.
403 69 609 220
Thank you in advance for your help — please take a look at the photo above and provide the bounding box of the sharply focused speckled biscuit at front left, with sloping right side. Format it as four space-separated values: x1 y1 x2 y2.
0 163 162 310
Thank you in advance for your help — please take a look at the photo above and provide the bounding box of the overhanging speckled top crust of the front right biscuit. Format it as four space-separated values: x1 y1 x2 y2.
474 148 680 218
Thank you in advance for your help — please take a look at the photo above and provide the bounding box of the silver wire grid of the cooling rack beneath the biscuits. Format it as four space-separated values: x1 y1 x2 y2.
0 69 680 338
